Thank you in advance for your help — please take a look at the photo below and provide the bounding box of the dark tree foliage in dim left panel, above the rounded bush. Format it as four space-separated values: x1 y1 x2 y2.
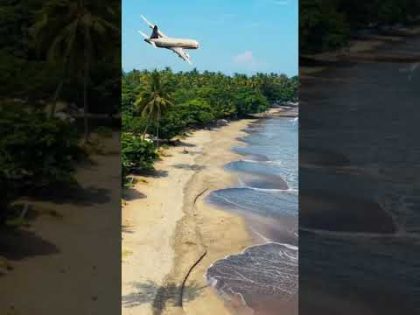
0 0 120 113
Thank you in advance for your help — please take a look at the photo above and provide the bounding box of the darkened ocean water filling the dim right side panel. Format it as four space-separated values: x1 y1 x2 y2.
299 37 420 315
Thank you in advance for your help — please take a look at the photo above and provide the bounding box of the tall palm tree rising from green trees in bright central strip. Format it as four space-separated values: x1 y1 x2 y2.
135 71 173 146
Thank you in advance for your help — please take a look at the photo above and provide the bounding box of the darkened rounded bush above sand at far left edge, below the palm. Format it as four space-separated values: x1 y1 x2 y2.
0 106 81 222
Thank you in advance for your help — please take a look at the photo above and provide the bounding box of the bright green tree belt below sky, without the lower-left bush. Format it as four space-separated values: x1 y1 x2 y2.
122 68 298 135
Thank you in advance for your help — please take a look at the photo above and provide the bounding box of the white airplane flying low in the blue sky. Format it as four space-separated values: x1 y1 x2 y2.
139 15 199 65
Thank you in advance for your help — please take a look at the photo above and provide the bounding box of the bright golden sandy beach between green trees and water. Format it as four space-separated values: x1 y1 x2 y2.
122 119 262 315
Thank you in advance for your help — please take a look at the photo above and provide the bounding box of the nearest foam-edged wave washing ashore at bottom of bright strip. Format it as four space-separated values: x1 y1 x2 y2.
205 242 298 307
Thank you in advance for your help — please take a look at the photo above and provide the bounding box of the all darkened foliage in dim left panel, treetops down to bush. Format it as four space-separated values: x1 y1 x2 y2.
0 0 121 220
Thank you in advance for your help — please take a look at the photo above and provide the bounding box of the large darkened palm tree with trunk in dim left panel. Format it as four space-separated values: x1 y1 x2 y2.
32 0 119 140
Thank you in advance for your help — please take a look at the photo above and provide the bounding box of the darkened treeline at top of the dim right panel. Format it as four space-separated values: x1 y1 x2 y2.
299 0 420 53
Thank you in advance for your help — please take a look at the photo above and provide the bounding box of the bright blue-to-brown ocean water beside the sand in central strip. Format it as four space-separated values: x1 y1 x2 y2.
206 117 298 315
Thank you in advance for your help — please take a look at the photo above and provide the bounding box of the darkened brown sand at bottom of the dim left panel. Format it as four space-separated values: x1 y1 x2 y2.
0 133 121 315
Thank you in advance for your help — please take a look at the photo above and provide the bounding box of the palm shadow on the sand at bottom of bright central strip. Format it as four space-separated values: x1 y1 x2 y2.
122 281 204 315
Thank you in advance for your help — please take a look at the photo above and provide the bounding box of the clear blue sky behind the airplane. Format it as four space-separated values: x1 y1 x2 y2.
122 0 298 76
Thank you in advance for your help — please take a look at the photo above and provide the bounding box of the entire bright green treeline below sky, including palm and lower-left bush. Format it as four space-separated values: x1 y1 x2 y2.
122 68 298 184
